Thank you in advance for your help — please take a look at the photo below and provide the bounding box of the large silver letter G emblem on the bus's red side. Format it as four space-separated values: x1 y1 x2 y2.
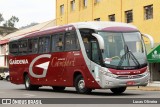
29 54 51 78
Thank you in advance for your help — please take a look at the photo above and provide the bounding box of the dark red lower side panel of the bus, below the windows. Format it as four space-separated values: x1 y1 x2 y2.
10 51 100 88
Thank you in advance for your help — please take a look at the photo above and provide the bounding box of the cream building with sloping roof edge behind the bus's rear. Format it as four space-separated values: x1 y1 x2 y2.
0 20 56 67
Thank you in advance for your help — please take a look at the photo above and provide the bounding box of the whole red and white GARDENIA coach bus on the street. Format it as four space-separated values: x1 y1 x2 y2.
9 21 154 94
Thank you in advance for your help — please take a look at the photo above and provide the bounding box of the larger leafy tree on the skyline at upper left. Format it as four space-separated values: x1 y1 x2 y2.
3 16 19 28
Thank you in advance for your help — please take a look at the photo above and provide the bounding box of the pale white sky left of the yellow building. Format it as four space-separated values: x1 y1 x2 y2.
0 0 56 28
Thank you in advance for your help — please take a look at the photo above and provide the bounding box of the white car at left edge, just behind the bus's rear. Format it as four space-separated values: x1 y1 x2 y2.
0 67 9 80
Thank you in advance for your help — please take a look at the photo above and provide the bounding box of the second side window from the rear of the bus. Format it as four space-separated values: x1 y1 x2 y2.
19 40 27 55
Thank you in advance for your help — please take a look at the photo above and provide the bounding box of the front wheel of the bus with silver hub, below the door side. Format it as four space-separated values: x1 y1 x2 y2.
75 75 92 94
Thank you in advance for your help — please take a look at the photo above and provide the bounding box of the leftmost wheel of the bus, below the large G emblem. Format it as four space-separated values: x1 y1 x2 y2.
24 74 39 90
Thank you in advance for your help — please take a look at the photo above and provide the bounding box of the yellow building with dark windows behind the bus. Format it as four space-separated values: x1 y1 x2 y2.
56 0 160 81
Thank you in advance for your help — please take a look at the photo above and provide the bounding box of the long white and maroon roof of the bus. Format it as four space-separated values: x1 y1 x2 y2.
10 21 138 41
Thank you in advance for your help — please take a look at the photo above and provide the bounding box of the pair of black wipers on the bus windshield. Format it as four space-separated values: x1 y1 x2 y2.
117 44 140 69
